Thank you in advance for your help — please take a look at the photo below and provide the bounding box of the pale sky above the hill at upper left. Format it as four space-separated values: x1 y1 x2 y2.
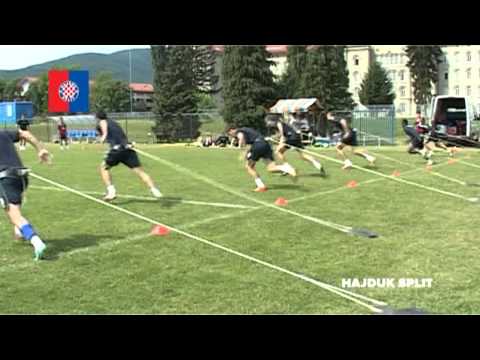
0 45 150 70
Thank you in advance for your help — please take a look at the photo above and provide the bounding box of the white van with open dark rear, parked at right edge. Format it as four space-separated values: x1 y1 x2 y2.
429 95 480 141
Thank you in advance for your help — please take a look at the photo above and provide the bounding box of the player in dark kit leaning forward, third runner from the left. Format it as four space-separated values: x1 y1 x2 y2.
227 126 297 192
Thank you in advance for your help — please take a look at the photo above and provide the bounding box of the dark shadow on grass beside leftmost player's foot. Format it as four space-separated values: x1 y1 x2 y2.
45 234 115 261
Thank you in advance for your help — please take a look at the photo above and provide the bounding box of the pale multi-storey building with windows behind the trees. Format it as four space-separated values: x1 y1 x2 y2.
216 45 480 117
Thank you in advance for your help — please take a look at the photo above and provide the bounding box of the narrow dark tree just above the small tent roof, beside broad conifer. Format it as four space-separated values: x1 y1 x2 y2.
279 45 307 99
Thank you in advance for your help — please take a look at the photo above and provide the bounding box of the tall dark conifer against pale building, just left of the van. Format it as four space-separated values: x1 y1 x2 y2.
405 45 443 113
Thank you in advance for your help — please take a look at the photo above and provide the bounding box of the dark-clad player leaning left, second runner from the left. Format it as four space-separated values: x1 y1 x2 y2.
96 111 162 201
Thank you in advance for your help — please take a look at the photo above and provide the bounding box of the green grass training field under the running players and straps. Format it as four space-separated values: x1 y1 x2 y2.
0 145 480 314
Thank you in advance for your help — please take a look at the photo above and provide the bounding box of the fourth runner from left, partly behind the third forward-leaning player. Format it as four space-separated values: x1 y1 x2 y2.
266 115 326 176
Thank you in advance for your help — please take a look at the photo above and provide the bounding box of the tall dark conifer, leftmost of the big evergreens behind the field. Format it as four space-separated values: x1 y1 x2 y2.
152 45 200 140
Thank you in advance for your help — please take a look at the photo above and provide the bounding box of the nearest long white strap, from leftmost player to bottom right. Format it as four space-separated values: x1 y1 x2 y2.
25 173 387 313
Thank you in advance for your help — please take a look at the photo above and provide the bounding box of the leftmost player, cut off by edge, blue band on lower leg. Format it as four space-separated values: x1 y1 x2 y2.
0 129 49 260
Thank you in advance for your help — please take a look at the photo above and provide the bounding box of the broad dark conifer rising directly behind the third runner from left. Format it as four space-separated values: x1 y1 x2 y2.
222 45 276 130
